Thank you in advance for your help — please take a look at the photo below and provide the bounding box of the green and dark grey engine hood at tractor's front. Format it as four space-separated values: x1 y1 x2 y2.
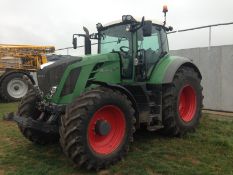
37 53 120 100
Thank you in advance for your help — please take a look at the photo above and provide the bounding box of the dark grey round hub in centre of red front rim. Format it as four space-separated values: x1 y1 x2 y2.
95 120 111 136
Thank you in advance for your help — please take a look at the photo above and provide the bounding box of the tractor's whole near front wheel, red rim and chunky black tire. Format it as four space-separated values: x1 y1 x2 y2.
60 88 135 170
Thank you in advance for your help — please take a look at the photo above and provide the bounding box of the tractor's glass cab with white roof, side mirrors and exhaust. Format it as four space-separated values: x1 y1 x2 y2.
73 15 171 81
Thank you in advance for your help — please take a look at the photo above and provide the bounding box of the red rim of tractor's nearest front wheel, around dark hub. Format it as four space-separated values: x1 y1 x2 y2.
88 105 126 155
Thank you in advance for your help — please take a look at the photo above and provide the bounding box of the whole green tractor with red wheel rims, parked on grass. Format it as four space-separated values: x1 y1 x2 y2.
14 8 203 170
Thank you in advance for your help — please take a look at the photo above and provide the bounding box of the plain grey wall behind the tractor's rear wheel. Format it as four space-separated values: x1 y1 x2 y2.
171 45 233 112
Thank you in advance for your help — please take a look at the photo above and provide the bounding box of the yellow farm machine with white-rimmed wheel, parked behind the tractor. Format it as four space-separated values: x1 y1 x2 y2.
0 44 55 101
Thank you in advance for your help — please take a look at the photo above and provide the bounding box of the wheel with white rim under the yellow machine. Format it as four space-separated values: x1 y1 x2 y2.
0 73 29 102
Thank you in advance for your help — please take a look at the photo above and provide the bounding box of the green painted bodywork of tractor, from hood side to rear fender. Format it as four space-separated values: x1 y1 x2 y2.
46 20 195 104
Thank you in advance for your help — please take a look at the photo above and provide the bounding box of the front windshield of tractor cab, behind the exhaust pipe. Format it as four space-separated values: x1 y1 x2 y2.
99 24 132 54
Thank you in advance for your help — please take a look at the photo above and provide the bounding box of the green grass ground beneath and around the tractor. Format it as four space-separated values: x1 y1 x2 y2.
0 104 233 175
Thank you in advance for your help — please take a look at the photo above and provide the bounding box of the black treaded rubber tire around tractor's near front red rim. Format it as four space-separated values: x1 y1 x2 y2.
60 87 136 170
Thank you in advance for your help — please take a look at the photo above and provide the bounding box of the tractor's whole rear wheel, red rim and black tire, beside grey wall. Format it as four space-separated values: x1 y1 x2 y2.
161 67 203 136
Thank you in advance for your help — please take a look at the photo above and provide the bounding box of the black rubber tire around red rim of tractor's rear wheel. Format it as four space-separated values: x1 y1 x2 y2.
160 67 203 136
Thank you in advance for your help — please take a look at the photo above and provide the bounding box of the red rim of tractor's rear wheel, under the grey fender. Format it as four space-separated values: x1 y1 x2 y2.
178 85 197 122
